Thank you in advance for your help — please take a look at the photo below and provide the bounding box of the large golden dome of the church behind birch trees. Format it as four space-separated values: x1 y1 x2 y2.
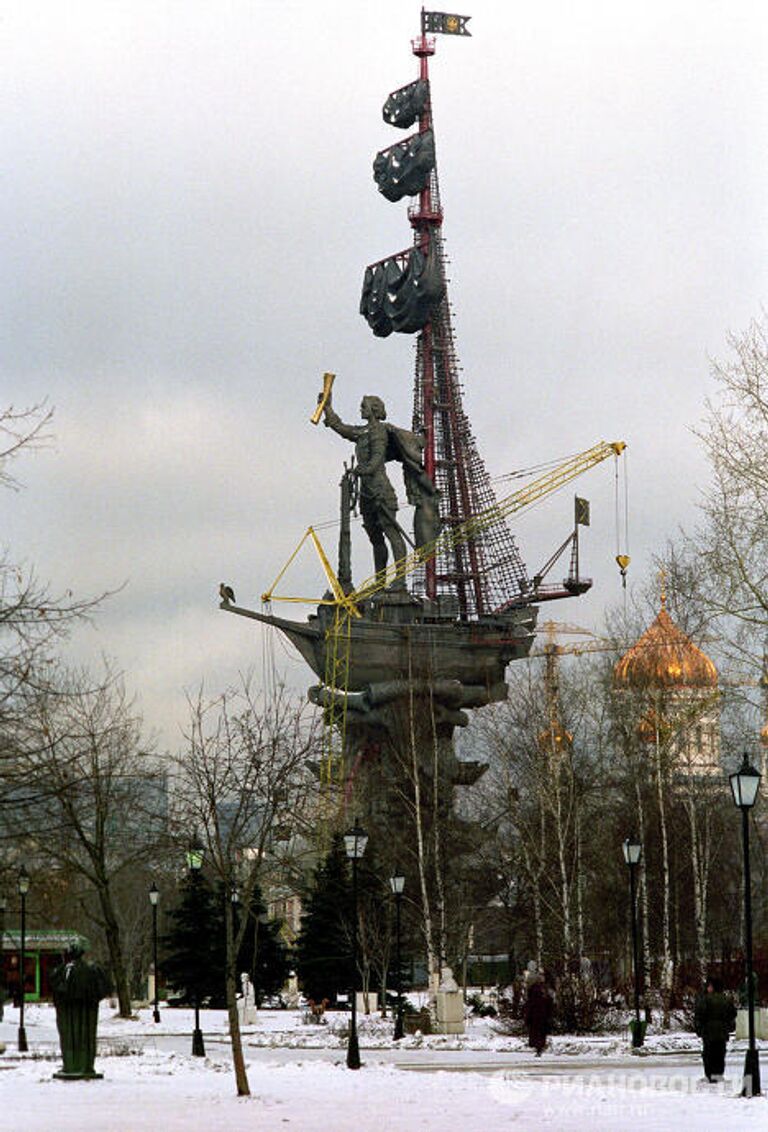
614 599 717 688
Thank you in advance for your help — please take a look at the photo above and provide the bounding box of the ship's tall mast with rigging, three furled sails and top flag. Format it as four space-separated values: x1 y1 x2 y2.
360 11 530 620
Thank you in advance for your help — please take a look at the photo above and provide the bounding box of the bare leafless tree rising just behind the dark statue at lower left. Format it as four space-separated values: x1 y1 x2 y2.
3 667 160 1018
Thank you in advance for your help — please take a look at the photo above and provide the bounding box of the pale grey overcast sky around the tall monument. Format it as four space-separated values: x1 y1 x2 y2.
0 0 768 746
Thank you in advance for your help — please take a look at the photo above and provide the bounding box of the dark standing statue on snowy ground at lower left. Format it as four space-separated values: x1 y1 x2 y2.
51 944 110 1080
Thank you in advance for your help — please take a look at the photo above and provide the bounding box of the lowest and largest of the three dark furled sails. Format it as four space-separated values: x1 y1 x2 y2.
360 245 445 338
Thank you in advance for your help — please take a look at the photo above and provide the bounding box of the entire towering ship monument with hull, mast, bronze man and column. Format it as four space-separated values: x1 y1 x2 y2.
221 11 623 978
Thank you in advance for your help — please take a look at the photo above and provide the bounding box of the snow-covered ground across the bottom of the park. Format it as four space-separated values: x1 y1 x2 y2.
0 1004 768 1132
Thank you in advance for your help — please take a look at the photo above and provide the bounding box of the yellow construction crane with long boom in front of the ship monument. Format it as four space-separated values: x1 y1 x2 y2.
262 440 629 782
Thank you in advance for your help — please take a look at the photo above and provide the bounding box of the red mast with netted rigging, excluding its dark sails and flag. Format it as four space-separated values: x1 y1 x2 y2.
408 33 530 618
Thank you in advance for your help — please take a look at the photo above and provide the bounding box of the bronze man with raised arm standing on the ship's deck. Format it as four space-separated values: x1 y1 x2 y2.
323 396 406 588
